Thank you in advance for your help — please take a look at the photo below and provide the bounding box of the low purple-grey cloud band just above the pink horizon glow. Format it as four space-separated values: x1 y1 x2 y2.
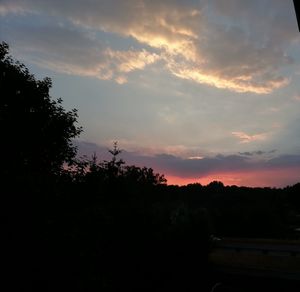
76 142 300 178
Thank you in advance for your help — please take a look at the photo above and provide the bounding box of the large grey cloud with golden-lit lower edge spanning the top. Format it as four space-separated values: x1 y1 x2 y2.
0 0 296 94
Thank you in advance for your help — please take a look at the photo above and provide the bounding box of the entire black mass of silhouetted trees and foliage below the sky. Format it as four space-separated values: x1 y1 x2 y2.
0 43 300 291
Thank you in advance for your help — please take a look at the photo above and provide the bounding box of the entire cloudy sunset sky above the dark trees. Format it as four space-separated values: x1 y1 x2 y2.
0 0 300 187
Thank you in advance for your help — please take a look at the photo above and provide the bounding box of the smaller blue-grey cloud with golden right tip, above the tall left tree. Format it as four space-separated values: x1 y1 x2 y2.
4 25 159 84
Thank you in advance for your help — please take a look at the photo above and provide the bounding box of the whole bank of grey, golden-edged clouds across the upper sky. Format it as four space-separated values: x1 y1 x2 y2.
0 0 297 94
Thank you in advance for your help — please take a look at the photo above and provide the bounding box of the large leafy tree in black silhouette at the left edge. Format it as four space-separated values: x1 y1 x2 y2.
0 42 82 174
